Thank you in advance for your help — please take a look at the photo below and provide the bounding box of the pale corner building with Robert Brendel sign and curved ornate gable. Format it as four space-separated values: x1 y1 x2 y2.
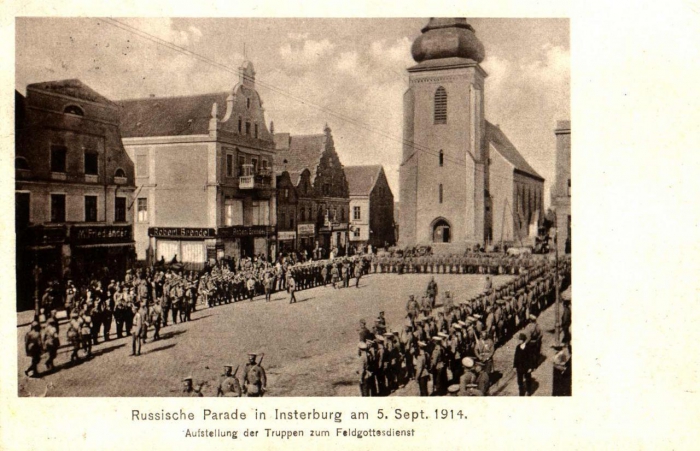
119 61 277 267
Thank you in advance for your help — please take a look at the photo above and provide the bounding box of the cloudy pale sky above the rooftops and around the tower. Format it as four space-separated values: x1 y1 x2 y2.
15 18 570 205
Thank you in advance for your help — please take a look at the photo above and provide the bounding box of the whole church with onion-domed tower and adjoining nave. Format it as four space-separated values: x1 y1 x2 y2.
399 18 544 253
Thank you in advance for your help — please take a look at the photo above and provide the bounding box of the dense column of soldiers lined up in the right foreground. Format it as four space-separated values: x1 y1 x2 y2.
357 260 571 396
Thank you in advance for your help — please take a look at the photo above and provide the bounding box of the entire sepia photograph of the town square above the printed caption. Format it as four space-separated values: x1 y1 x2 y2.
15 17 568 402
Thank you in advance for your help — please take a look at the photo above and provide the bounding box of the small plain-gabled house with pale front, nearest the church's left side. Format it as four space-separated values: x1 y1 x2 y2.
345 165 395 248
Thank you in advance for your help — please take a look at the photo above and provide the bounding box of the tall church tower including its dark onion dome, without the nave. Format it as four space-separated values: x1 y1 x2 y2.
399 18 489 253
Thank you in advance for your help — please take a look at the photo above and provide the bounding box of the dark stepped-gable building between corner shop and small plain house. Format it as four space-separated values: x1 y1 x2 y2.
275 126 350 256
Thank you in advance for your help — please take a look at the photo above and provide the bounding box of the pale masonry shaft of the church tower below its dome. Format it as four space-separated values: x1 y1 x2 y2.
400 66 485 251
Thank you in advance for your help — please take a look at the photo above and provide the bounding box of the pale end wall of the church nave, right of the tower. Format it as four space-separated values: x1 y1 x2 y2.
489 146 514 243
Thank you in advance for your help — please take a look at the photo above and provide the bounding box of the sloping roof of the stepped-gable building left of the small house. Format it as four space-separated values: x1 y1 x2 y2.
275 133 326 185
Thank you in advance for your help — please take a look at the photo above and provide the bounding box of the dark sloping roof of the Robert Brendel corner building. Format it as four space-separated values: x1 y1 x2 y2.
117 92 224 138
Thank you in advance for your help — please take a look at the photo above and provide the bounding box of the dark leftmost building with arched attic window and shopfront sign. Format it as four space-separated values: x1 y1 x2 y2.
15 79 135 309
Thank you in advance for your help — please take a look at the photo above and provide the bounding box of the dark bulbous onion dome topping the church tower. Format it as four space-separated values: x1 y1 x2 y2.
411 17 485 63
